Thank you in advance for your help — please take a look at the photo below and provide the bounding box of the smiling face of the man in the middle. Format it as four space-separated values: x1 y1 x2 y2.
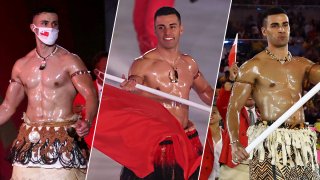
155 14 183 49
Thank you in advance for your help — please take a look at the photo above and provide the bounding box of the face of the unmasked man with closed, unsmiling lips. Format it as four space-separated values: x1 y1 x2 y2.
261 14 290 47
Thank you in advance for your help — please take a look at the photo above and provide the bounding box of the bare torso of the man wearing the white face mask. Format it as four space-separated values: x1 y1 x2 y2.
18 48 76 120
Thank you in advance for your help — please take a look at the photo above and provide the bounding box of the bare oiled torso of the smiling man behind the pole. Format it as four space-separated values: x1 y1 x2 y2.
131 50 197 128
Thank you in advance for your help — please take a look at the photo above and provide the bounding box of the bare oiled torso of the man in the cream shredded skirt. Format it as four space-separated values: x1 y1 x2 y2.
239 52 311 124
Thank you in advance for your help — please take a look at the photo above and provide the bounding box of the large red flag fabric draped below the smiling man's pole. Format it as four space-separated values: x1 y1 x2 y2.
93 85 201 179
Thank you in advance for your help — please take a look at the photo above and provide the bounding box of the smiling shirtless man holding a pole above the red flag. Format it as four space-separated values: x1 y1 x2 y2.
121 7 213 179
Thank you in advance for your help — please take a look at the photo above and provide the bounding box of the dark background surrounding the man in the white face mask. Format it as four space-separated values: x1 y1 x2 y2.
0 0 117 180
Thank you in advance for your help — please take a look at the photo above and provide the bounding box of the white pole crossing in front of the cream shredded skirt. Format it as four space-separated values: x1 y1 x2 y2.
246 82 320 153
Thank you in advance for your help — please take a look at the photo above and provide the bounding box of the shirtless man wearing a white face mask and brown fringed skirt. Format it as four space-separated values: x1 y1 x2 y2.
0 8 98 179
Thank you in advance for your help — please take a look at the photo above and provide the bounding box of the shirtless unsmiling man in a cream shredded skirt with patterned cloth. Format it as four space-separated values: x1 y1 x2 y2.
227 8 320 179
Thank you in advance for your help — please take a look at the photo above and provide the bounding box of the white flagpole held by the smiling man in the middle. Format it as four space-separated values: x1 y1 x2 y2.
105 74 211 112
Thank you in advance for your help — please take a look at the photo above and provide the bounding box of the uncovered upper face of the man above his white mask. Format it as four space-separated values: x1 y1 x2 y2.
30 12 59 31
